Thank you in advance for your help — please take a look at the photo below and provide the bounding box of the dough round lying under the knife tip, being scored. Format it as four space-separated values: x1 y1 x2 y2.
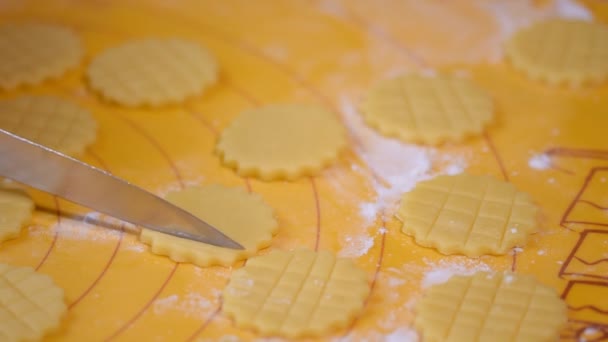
140 185 278 267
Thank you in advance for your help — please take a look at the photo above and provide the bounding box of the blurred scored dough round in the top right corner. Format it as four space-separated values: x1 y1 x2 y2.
505 19 608 85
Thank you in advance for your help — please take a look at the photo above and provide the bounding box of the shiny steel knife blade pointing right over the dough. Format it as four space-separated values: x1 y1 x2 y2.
0 129 243 249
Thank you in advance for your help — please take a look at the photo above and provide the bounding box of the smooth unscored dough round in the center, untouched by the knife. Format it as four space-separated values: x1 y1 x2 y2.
216 104 346 180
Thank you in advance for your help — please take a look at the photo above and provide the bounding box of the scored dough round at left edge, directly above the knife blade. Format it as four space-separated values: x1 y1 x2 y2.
0 96 97 155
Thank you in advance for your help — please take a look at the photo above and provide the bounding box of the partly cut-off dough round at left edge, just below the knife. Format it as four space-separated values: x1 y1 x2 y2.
0 187 34 242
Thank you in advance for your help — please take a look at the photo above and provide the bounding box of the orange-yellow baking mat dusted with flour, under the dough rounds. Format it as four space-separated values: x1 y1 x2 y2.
0 0 608 341
